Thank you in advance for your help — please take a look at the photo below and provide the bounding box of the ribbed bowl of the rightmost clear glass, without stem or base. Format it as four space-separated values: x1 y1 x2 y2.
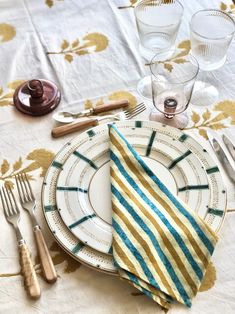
190 10 235 71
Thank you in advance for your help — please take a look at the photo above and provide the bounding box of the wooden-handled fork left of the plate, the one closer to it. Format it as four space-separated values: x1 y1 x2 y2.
15 173 57 283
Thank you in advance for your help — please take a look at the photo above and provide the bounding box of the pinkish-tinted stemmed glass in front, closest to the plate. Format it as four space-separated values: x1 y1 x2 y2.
150 51 199 129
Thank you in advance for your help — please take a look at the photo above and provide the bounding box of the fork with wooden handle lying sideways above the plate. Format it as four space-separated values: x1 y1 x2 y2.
51 103 146 137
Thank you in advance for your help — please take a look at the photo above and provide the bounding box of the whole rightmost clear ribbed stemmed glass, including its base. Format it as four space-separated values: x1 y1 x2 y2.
190 9 235 105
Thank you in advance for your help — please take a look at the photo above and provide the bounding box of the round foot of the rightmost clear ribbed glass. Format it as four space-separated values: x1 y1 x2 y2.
191 81 219 106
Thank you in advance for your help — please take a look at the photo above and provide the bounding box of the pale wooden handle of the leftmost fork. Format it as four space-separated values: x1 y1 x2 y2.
19 243 41 299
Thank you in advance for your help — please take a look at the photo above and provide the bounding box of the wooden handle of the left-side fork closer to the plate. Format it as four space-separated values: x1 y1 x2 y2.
34 226 57 283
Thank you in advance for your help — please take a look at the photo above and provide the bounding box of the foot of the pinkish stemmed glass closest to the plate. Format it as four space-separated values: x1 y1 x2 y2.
149 109 189 129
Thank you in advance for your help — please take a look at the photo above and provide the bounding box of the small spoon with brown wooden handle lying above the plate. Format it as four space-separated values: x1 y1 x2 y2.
53 99 129 123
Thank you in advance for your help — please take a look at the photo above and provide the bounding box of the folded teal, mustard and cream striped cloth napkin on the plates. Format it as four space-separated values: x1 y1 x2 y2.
109 125 217 310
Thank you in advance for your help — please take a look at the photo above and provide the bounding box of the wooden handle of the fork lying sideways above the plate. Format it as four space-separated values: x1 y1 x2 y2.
51 119 98 137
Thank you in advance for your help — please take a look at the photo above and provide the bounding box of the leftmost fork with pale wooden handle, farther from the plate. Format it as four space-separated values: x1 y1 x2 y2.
0 187 41 299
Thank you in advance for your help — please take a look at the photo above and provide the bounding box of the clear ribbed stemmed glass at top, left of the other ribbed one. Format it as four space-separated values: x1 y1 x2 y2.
134 0 184 99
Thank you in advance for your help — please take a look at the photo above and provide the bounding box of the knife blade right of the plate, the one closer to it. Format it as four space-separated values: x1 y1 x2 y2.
207 130 235 183
